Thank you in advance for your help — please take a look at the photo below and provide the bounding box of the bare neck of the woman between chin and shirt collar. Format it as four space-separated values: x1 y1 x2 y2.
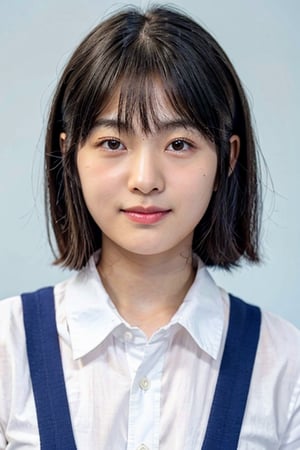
98 243 195 337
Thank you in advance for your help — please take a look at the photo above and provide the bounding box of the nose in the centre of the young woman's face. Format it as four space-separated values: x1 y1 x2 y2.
128 148 165 195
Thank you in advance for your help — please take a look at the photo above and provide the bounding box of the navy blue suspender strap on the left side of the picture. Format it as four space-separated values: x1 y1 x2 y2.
22 287 76 450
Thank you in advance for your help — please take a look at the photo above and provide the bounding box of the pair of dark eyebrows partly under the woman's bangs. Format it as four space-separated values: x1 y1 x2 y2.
93 117 199 132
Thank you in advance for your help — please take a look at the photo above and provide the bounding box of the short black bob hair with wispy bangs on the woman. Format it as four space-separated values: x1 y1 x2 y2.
45 6 261 270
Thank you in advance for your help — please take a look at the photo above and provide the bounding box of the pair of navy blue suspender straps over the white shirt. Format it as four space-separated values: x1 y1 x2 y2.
22 288 261 450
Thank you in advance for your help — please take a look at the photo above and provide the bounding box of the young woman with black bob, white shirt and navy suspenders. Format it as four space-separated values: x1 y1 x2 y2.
0 7 300 450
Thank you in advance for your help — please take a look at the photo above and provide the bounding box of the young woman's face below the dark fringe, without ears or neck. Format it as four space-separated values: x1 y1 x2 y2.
77 90 217 256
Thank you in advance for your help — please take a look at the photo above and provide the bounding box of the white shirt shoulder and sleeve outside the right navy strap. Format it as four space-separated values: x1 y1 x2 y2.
225 296 300 442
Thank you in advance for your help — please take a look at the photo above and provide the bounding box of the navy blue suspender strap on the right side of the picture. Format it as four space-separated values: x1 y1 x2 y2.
202 295 261 450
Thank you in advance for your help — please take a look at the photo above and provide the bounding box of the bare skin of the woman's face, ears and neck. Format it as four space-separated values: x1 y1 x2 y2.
61 87 239 337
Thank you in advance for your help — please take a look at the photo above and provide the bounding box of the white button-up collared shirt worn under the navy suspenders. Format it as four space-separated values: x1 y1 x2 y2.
0 258 300 450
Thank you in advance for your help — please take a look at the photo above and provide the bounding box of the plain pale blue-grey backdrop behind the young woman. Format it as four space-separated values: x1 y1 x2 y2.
0 0 300 327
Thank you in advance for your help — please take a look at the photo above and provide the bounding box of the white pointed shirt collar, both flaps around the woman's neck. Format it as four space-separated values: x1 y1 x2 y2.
65 255 224 359
